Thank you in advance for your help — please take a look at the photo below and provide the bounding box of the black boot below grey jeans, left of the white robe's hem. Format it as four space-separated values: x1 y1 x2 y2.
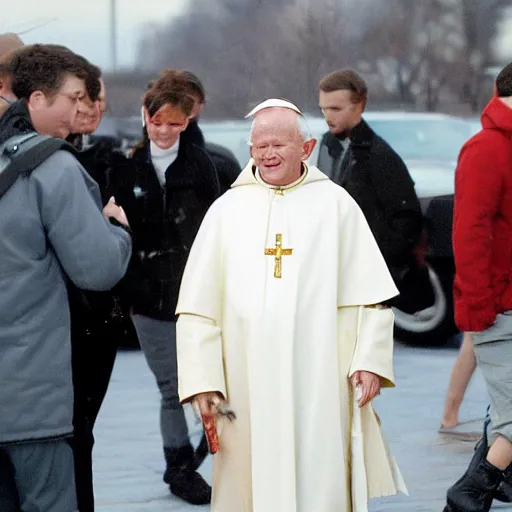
164 444 212 505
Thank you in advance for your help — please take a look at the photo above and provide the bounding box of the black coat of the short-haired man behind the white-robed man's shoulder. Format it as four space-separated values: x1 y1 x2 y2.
318 120 423 283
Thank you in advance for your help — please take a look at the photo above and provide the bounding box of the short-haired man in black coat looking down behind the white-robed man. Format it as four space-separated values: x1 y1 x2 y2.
318 70 422 288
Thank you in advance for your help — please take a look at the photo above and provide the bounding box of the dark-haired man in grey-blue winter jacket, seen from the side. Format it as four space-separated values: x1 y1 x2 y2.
0 45 131 512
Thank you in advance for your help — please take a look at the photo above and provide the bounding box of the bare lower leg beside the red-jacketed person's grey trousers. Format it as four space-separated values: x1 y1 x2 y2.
441 333 476 429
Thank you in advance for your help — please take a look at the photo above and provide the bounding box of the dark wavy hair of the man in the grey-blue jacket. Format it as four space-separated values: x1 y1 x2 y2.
4 44 95 99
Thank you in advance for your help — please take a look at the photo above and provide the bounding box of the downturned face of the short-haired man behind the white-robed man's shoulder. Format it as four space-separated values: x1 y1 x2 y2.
319 91 364 134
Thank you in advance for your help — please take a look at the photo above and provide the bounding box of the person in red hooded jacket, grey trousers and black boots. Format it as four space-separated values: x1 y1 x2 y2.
444 64 512 512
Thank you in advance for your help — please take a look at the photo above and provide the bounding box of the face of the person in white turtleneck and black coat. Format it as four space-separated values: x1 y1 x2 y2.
144 104 190 149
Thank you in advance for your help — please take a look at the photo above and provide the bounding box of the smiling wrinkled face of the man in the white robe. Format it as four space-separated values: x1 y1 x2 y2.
251 108 314 186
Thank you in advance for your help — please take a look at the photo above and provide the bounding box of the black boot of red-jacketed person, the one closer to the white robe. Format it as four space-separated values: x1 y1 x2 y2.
444 460 503 512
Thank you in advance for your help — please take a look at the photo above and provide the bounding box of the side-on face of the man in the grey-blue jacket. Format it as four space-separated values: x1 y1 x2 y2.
28 75 87 139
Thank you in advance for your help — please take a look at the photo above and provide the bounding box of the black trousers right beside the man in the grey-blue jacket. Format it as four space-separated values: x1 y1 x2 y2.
70 323 119 512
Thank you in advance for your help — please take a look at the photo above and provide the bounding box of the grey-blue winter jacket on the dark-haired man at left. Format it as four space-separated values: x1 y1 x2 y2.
0 151 131 445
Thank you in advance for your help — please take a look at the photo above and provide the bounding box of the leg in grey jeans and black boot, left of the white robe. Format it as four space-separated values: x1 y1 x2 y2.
133 315 211 505
